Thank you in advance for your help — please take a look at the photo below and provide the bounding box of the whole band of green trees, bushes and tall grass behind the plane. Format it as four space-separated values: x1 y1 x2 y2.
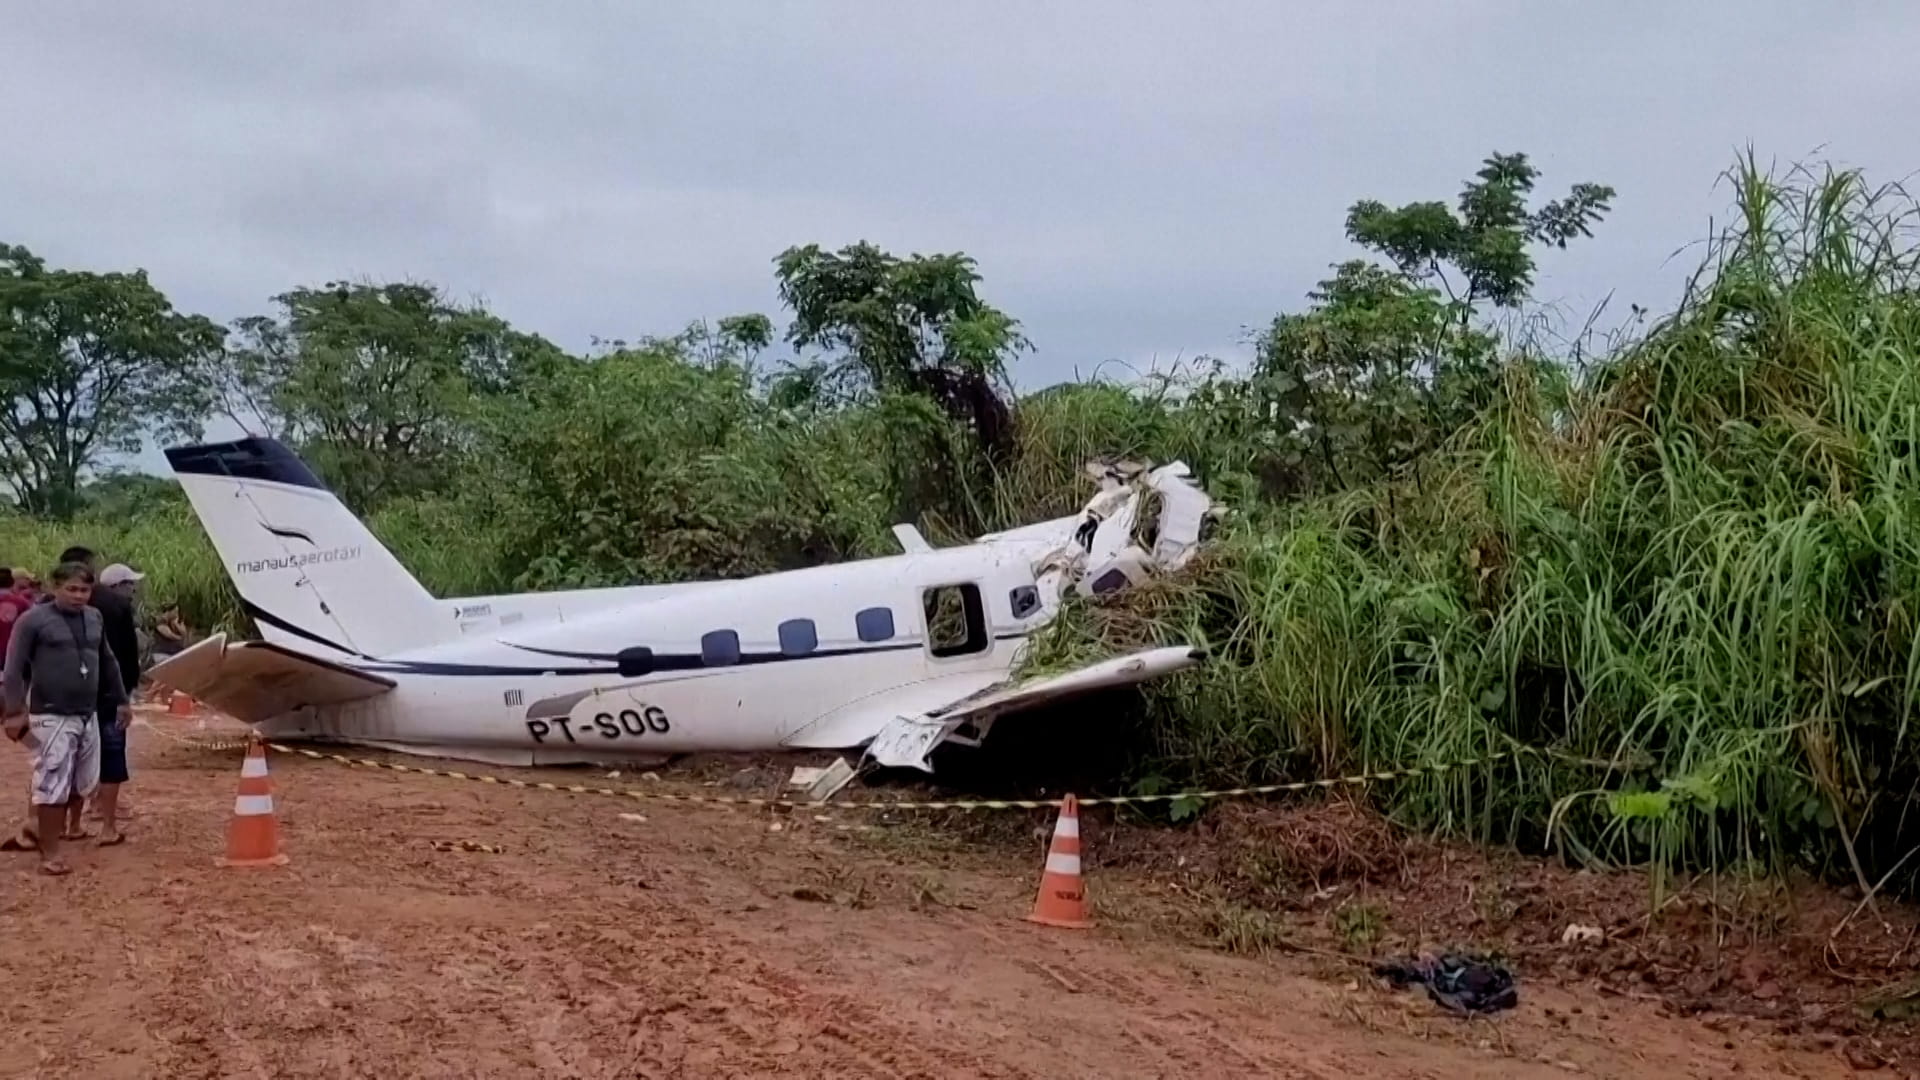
0 148 1920 890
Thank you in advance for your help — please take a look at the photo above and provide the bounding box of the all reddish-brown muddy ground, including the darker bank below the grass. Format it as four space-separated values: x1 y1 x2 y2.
0 713 1920 1080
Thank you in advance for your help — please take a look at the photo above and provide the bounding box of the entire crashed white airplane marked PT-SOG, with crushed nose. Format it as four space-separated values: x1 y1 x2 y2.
154 438 1215 771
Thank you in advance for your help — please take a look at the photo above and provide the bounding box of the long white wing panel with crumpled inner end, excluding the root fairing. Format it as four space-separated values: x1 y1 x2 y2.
848 646 1200 773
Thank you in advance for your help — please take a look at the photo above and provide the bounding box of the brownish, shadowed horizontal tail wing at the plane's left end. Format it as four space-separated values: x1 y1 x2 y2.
150 634 394 724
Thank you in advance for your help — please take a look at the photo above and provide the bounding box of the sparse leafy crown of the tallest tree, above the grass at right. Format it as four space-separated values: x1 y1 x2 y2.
1346 154 1615 321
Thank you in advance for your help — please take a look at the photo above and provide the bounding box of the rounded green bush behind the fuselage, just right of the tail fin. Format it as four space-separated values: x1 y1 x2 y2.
461 340 883 588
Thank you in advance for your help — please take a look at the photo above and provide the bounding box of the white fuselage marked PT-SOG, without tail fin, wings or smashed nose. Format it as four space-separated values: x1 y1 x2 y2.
261 523 1071 765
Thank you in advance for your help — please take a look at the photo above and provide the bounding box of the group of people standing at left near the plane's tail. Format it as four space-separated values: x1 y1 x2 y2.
0 548 186 874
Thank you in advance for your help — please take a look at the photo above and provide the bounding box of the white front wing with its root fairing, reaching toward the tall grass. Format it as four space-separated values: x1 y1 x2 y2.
789 646 1202 773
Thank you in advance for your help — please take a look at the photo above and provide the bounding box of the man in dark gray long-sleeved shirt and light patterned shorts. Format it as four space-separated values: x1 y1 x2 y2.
4 563 132 874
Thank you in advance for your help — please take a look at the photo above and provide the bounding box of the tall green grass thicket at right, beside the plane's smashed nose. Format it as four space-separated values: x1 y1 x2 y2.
1035 161 1920 887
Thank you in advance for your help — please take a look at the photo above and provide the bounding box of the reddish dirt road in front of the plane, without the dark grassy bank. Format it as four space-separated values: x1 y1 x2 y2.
0 717 1853 1080
